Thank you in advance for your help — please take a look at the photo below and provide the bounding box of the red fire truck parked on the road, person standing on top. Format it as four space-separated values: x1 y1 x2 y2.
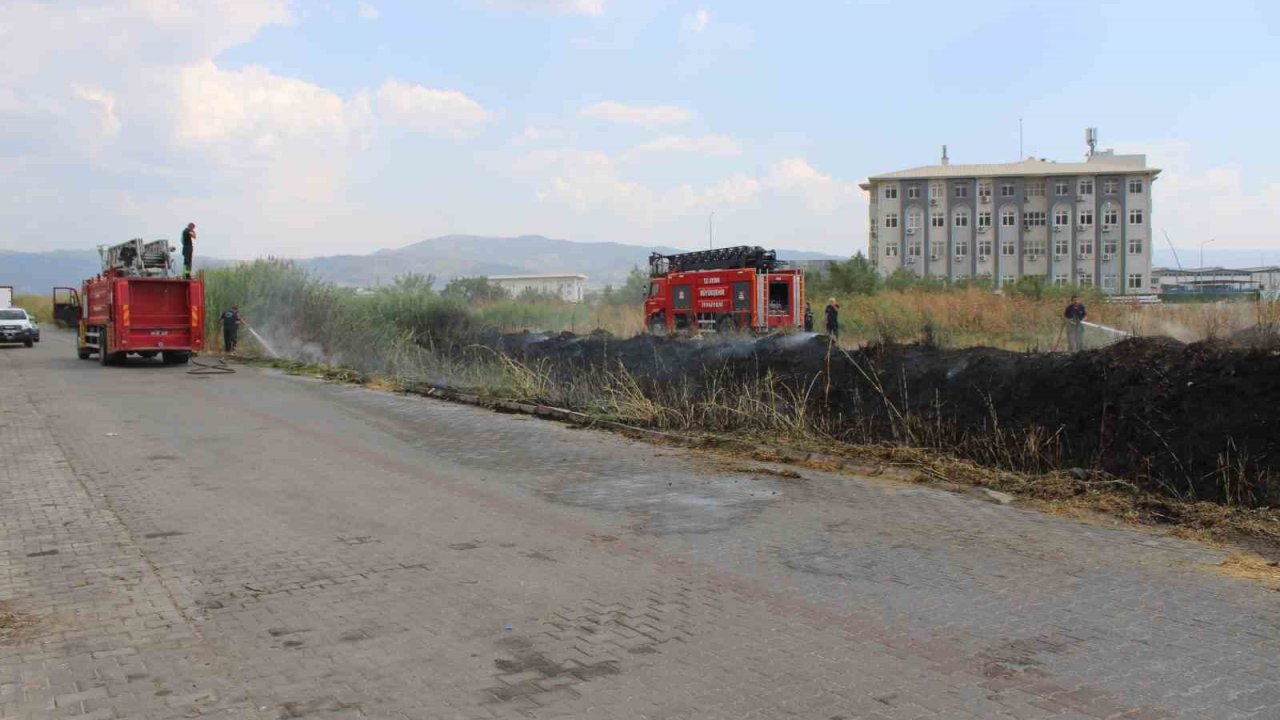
54 240 205 365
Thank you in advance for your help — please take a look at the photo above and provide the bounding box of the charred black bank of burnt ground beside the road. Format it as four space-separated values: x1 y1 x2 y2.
494 333 1280 506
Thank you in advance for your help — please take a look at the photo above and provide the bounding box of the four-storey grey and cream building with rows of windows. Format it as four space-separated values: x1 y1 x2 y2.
861 128 1160 295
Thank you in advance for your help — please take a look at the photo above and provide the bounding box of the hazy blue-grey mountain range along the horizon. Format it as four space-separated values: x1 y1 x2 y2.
0 234 835 295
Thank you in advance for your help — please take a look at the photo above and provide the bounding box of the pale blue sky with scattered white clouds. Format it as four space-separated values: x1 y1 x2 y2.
0 0 1280 263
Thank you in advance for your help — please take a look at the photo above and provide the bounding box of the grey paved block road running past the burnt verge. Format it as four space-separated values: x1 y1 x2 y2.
0 333 1280 720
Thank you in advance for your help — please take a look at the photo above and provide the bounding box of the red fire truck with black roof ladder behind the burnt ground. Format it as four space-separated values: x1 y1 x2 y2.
644 246 804 333
